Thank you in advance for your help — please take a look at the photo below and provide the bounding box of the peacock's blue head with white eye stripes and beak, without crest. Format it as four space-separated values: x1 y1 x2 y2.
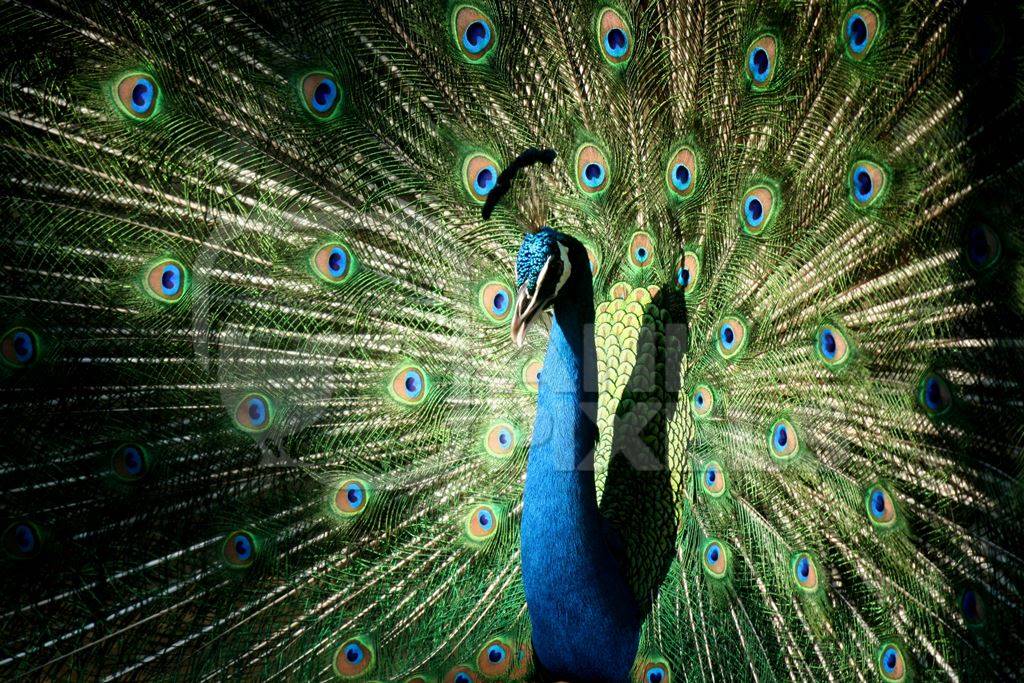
512 226 589 346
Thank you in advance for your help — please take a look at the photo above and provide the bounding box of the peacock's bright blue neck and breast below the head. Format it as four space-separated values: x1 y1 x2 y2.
521 271 639 681
